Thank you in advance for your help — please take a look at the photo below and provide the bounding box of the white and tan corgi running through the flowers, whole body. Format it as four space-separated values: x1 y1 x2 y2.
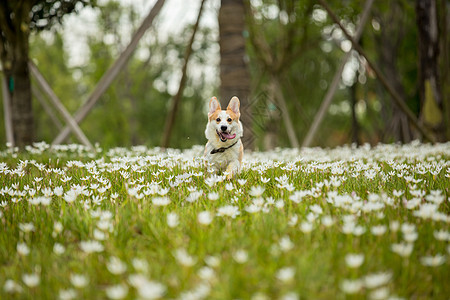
204 97 244 180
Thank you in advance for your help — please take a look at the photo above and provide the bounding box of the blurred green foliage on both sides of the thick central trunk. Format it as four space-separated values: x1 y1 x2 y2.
0 0 448 149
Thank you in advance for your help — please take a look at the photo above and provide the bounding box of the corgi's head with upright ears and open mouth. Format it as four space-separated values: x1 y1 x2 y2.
205 97 242 144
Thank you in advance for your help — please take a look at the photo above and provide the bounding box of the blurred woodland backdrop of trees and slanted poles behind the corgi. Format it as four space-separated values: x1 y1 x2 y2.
0 0 450 150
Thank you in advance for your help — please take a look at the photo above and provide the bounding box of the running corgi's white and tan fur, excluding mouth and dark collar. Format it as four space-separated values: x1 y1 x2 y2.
205 97 243 179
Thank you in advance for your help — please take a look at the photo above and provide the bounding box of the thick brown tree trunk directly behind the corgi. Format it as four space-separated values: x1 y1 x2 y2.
219 0 254 149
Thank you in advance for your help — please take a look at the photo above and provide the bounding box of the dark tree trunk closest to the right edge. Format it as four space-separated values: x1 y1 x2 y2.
416 0 445 141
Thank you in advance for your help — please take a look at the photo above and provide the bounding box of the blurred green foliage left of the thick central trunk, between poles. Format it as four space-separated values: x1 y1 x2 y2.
19 1 218 147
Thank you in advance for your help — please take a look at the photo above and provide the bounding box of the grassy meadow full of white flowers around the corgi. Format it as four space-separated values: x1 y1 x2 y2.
0 142 450 299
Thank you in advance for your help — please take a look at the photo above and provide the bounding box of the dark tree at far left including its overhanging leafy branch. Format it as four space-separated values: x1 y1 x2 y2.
0 0 95 147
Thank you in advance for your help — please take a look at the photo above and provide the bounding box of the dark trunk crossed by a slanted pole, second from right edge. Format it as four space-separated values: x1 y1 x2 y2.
373 1 417 143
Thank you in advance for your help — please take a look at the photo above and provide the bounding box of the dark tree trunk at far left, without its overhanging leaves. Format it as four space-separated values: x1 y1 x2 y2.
0 1 34 148
